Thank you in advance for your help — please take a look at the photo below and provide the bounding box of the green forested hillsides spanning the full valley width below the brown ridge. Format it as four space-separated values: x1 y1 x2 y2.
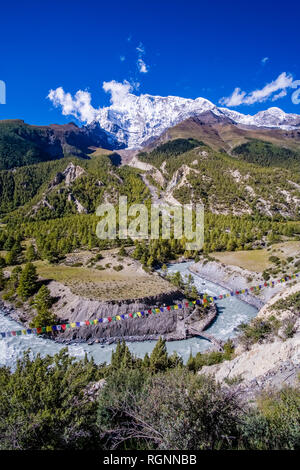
0 139 300 268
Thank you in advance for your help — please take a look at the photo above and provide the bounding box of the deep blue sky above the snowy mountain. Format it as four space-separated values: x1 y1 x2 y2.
0 0 300 124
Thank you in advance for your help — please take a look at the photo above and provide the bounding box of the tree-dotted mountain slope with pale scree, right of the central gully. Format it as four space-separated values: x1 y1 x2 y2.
134 139 300 219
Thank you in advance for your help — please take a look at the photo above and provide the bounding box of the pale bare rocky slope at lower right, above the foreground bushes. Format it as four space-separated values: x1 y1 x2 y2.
199 283 300 397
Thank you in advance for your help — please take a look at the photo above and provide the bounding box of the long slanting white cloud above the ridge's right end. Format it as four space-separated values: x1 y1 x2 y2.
219 72 294 106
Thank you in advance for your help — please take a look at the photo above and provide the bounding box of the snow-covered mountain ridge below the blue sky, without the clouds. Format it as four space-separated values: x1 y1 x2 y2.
95 94 300 149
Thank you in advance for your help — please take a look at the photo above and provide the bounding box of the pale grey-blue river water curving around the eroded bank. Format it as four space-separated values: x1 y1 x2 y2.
0 263 257 367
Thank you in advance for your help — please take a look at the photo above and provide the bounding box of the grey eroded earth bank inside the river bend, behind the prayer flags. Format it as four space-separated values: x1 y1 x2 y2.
0 288 218 345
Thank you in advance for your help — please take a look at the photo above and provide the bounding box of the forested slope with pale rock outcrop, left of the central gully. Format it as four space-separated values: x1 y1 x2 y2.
0 150 149 220
